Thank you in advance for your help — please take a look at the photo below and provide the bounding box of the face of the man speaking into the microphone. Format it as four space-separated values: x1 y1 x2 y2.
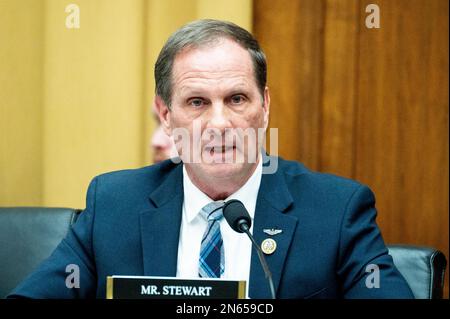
160 39 269 185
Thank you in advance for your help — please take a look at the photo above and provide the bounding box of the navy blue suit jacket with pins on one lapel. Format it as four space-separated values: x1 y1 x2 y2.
10 158 413 298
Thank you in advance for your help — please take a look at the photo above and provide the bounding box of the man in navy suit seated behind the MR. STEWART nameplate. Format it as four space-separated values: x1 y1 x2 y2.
11 20 412 298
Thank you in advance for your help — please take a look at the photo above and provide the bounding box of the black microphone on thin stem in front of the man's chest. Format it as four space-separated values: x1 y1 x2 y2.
223 199 275 299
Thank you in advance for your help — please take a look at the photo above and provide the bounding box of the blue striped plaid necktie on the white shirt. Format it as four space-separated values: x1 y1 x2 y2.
198 201 225 278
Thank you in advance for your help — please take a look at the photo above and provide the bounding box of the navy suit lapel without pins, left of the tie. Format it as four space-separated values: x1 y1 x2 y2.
140 165 183 277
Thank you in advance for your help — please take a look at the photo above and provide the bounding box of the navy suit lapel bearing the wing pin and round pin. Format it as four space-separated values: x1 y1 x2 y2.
249 162 298 299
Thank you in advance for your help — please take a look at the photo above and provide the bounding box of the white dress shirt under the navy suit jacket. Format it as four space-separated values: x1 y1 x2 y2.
177 157 262 288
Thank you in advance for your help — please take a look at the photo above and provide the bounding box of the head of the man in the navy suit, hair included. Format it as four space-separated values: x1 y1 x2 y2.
155 20 270 199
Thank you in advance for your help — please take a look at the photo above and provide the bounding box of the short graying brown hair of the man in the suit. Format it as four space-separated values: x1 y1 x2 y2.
155 19 267 108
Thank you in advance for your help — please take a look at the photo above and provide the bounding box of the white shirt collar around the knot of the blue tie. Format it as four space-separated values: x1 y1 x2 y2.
183 156 262 223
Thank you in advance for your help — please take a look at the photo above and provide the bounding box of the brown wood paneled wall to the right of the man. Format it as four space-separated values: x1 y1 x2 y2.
254 0 449 296
